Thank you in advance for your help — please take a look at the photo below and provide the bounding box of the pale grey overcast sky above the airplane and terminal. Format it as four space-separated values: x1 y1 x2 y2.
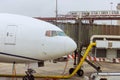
0 0 120 17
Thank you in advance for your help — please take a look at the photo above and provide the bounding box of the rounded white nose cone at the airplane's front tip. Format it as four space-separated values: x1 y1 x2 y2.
65 37 77 54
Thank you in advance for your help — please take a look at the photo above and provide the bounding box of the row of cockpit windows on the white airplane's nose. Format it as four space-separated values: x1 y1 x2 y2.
45 30 66 37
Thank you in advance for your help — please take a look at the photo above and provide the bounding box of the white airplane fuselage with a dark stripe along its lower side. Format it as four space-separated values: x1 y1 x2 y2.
0 14 76 63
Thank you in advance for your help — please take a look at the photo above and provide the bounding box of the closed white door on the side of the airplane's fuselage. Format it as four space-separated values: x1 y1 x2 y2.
4 25 17 45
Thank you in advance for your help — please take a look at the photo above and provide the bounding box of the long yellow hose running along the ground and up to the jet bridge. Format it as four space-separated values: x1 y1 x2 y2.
0 43 96 79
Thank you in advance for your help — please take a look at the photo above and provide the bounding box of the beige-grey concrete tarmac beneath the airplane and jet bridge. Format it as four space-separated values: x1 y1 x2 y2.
0 60 120 80
